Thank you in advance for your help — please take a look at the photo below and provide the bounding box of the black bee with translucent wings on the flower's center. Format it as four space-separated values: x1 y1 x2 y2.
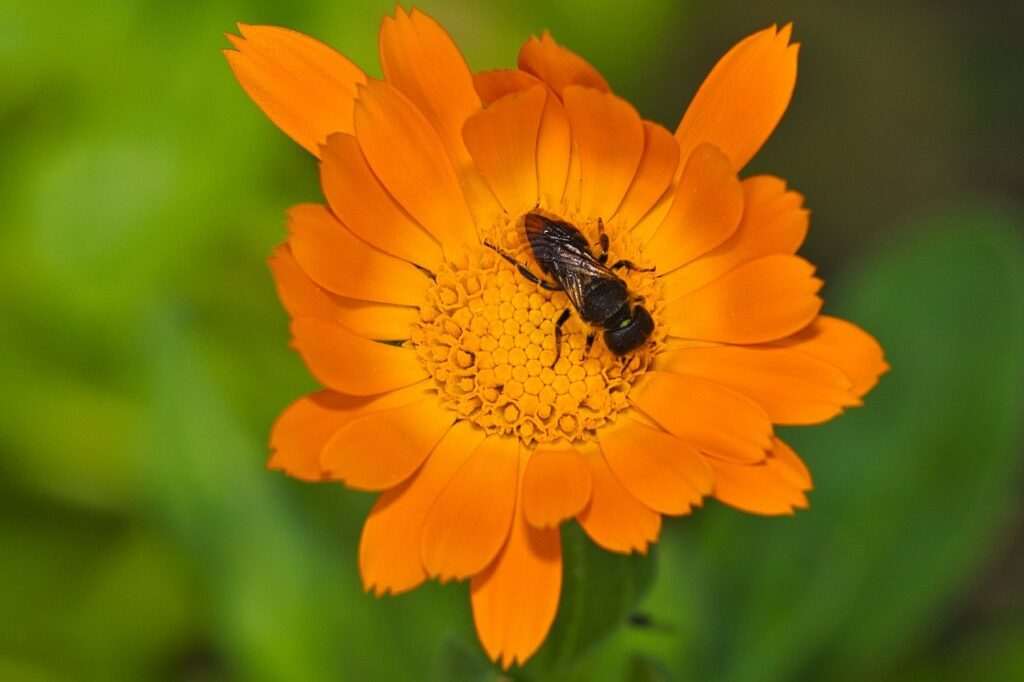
483 210 654 366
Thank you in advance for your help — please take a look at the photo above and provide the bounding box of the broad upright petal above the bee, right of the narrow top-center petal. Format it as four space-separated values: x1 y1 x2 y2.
562 85 644 217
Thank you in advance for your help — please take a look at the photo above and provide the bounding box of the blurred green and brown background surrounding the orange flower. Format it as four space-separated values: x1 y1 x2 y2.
0 0 1024 681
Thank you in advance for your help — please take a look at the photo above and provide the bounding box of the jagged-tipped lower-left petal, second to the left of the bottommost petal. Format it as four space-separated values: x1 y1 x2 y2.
359 421 483 597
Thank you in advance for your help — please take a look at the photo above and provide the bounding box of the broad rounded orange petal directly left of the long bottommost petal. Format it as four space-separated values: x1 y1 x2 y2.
422 436 519 582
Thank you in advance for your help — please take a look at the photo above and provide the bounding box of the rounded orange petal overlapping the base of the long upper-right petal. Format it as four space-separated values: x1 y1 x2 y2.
644 145 743 274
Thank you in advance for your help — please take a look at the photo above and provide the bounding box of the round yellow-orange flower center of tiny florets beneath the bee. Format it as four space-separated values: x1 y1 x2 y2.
412 216 665 447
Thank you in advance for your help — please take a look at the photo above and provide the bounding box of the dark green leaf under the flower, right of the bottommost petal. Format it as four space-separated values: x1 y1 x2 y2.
523 523 654 679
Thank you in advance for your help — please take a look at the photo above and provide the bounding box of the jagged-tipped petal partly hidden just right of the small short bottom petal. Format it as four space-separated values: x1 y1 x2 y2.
577 445 662 554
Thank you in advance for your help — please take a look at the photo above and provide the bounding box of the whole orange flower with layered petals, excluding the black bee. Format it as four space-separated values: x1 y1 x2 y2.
226 8 887 668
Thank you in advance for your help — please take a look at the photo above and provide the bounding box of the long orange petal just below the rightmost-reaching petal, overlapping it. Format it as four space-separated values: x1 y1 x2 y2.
656 346 860 424
